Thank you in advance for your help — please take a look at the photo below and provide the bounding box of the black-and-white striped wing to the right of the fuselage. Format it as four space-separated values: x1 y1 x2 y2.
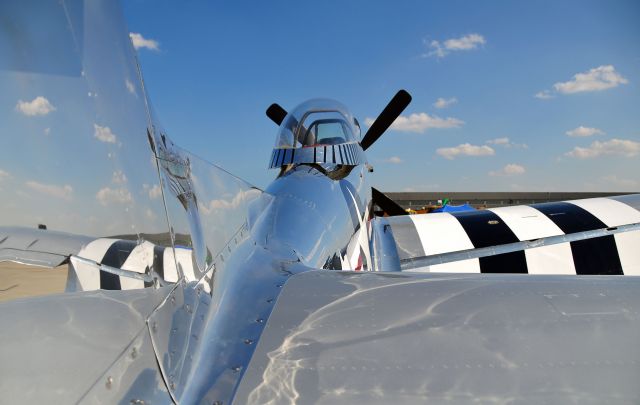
372 194 640 275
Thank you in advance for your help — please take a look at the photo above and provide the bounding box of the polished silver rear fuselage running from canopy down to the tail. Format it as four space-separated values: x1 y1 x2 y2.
180 164 371 403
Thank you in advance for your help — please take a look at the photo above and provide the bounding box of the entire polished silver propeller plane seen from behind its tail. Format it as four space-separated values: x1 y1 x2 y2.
0 0 640 404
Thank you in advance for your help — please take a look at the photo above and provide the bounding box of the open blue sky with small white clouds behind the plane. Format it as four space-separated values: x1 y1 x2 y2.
123 0 640 191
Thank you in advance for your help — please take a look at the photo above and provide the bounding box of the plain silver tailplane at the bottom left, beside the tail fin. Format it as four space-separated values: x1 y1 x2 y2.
0 287 172 403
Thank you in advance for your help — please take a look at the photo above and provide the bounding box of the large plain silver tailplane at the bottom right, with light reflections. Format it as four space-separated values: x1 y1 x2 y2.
235 271 640 404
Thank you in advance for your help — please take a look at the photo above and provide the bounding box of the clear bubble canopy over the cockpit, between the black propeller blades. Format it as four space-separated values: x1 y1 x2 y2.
270 99 362 168
